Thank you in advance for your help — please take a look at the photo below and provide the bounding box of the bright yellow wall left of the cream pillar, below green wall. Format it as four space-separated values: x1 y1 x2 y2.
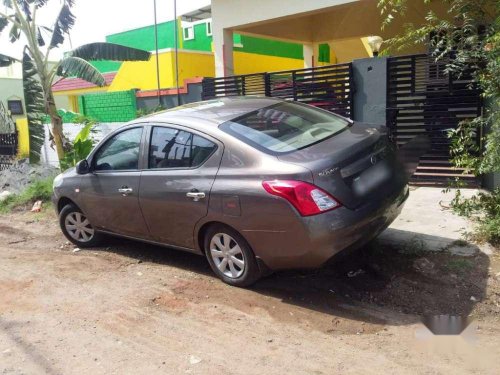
109 51 215 91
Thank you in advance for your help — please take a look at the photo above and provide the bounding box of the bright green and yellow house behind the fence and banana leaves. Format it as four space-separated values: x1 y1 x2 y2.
49 18 320 122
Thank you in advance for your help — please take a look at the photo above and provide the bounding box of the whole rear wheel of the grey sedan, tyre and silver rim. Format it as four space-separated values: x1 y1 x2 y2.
204 224 261 287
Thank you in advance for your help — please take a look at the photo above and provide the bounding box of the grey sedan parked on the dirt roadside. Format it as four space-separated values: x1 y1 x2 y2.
54 97 408 286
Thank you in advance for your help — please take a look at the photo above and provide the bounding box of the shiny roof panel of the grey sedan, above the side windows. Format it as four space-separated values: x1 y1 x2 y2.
144 96 283 126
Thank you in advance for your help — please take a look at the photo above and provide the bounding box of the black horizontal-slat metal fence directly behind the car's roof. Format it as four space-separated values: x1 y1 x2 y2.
202 63 354 117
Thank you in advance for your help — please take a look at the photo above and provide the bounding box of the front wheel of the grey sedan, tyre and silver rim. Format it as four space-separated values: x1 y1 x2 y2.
59 204 102 248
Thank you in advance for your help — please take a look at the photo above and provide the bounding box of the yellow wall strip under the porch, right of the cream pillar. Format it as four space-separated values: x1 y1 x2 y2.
233 52 304 74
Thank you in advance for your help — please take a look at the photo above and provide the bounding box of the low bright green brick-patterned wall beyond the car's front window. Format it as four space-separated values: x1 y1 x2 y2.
78 90 137 122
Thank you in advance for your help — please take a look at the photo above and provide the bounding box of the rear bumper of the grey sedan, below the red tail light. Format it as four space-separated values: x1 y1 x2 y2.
245 185 409 270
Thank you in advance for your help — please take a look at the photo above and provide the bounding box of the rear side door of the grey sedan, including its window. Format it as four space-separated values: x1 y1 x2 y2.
139 125 223 249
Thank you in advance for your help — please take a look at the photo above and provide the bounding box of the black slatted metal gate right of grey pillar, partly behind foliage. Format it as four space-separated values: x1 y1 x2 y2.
387 55 481 185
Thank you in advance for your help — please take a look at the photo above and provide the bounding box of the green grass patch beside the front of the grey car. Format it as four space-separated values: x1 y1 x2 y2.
0 177 54 213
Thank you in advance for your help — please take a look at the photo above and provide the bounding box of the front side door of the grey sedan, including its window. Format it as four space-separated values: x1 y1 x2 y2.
80 127 149 238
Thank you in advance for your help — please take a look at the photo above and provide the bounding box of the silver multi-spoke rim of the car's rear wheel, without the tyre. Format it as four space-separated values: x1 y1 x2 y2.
210 233 245 279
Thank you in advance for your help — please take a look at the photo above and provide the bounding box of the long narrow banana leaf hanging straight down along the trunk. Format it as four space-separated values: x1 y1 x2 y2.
23 50 45 163
